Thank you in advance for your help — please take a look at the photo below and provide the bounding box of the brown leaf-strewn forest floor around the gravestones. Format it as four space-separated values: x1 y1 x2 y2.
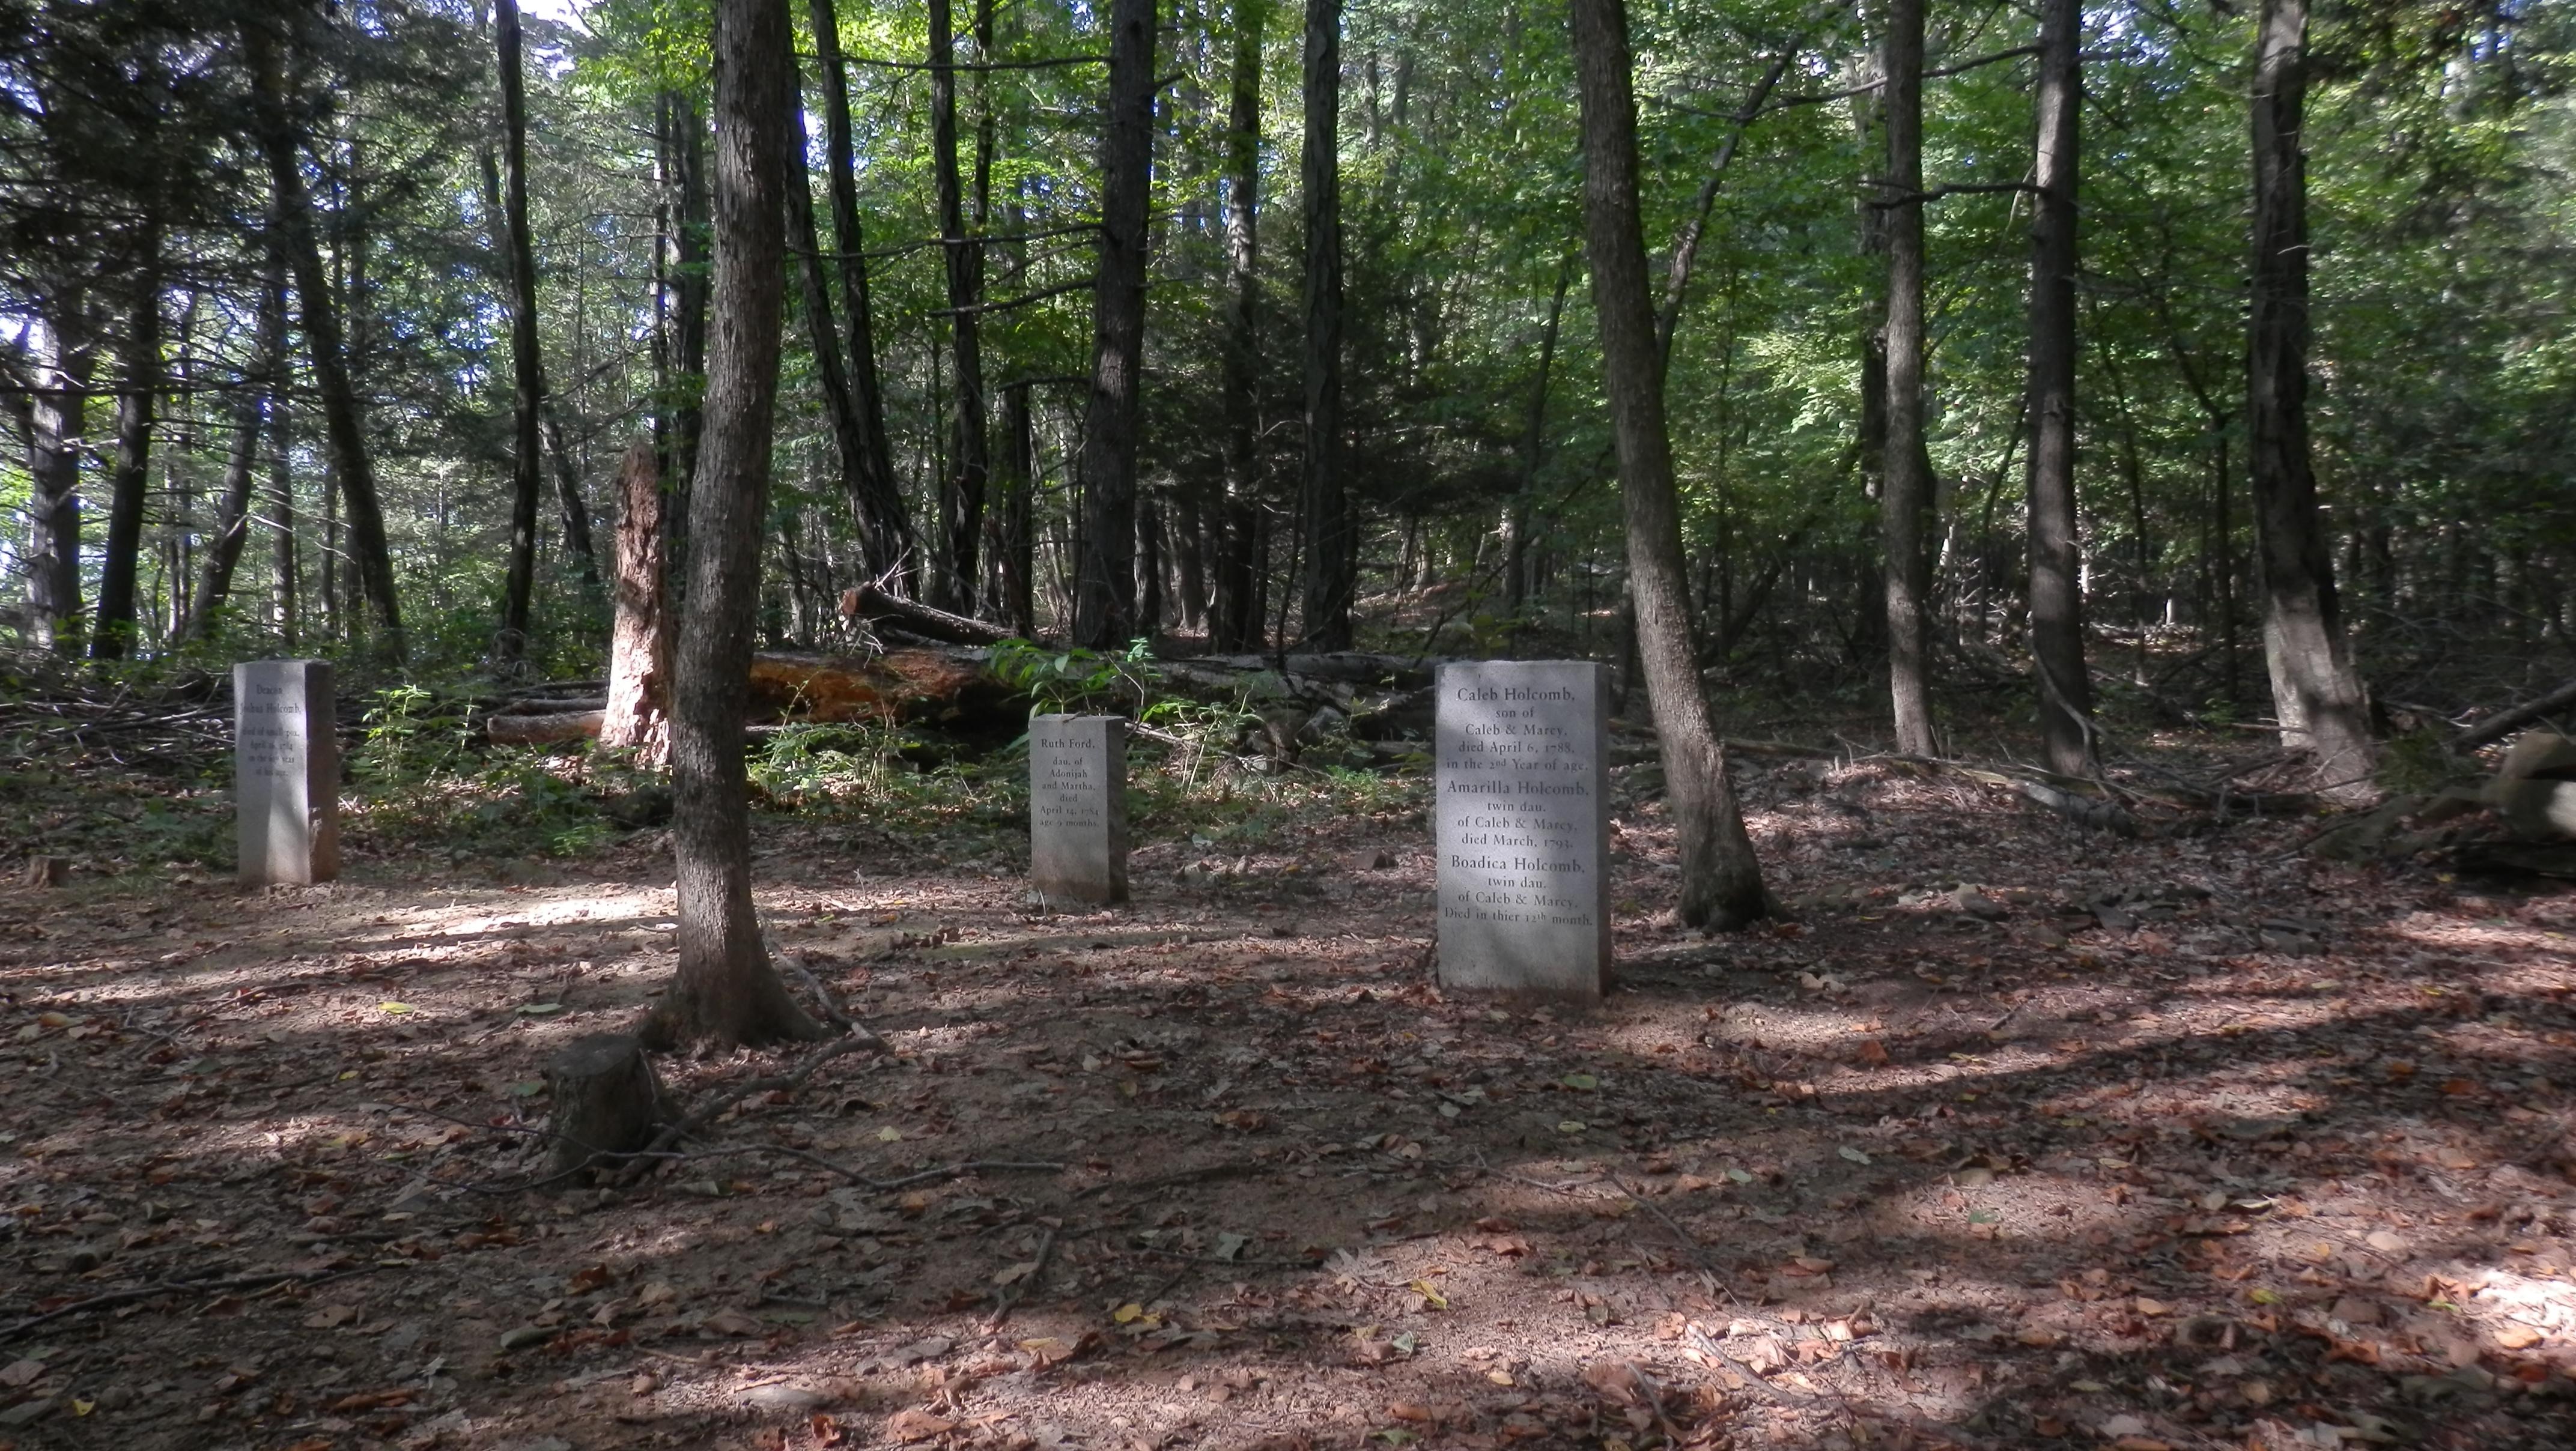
0 737 2576 1451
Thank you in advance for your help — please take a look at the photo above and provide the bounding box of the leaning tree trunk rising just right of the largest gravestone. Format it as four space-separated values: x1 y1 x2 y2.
1574 0 1770 928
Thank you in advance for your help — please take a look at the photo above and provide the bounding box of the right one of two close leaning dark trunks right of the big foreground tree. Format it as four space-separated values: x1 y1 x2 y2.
809 0 914 590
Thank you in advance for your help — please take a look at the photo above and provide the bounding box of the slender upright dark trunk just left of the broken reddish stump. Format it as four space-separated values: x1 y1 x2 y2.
492 0 546 662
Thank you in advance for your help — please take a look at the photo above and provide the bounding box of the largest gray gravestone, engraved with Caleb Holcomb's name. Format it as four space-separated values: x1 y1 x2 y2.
1435 660 1610 1002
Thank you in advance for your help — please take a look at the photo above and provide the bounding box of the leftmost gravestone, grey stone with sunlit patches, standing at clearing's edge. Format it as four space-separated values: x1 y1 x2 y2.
232 660 340 886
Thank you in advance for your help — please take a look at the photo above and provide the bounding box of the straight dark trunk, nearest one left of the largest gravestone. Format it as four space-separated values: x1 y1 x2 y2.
1208 0 1270 649
